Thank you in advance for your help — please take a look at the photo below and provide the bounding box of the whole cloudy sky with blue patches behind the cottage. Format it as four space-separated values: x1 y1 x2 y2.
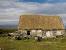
0 0 66 25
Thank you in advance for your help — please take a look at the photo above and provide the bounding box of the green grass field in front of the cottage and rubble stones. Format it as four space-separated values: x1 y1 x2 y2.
0 37 66 50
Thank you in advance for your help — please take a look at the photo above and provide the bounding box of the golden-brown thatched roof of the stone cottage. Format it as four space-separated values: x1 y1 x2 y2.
18 15 64 30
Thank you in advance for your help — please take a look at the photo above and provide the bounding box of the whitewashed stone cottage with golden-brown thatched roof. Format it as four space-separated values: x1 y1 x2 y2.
18 15 64 38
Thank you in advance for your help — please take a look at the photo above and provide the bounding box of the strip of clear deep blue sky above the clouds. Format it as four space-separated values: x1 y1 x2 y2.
18 0 66 3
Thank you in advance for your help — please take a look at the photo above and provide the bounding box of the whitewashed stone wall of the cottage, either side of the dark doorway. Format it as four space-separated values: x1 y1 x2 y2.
21 30 64 38
